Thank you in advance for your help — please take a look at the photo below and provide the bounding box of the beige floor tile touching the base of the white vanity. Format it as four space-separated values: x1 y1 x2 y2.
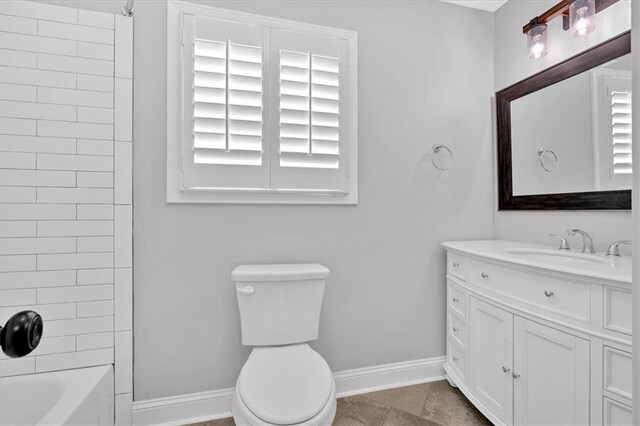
422 380 491 426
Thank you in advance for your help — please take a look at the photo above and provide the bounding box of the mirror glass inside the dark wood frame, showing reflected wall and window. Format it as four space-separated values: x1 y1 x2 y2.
511 54 632 196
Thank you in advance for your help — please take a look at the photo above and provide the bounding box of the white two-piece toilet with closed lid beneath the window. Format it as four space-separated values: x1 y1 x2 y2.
231 264 336 426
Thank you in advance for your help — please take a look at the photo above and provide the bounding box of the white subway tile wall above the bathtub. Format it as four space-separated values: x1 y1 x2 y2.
0 1 133 412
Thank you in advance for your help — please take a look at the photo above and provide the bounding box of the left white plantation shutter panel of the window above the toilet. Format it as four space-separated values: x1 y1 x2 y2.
183 15 269 188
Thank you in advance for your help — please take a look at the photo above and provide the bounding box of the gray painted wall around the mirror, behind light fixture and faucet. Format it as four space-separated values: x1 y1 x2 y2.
494 0 632 253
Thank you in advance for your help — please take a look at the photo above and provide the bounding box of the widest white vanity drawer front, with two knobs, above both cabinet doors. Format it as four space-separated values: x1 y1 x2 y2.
469 260 590 322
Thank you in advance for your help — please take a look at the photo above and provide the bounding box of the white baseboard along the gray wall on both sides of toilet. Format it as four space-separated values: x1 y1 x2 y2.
132 357 446 425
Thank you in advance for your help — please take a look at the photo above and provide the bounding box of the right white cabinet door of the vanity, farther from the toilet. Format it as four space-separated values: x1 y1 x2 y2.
513 316 589 425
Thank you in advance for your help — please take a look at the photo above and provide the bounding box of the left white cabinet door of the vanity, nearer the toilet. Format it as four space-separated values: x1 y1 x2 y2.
469 297 513 424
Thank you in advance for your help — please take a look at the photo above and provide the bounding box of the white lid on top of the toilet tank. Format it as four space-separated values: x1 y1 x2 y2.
231 263 329 282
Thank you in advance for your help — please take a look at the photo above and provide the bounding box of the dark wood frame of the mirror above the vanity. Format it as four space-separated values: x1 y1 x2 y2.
496 31 631 210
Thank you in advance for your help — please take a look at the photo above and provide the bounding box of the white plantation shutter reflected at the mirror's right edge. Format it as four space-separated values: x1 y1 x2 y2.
610 90 633 174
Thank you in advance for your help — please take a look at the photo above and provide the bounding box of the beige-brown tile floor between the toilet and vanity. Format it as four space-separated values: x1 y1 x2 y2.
193 380 491 426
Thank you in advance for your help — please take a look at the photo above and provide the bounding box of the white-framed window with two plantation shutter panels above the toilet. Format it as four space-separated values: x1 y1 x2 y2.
167 2 357 204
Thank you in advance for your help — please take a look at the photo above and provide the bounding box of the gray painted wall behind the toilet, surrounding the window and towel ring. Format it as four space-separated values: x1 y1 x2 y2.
33 0 495 400
